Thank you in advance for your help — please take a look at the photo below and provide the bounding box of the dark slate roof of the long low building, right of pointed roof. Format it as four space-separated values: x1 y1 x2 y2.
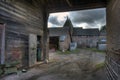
73 28 99 36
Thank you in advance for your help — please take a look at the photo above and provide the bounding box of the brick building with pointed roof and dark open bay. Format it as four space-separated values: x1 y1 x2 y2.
49 18 73 51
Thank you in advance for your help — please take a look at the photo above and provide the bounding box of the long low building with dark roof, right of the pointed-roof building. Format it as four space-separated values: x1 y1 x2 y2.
72 28 99 48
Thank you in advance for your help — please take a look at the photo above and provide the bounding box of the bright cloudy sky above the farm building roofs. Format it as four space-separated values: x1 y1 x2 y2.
48 8 106 29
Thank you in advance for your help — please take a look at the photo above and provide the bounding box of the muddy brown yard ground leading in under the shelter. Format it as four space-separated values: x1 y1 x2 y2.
0 49 106 80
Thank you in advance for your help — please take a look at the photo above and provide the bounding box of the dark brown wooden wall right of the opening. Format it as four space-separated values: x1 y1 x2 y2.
106 0 120 80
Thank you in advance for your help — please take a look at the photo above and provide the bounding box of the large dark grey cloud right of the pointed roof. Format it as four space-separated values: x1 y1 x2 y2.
70 9 106 25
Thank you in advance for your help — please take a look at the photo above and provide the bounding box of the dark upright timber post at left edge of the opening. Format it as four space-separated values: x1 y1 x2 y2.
43 1 49 63
